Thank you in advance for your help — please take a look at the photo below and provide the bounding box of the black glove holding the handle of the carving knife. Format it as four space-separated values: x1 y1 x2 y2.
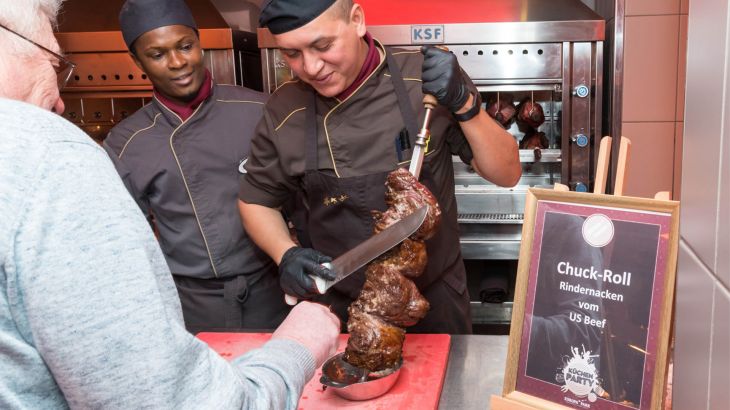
279 246 335 299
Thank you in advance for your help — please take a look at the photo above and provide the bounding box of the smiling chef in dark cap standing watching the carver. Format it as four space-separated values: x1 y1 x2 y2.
104 0 289 332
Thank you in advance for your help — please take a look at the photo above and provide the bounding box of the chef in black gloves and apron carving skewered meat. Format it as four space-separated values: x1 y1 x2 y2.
239 0 521 333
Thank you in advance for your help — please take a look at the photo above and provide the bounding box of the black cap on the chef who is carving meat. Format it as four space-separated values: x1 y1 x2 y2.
259 0 336 34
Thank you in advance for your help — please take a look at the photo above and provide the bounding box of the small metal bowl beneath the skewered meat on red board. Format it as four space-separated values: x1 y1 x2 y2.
319 352 403 400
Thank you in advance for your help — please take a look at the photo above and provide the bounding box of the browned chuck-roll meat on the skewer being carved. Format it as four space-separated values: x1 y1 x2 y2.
344 168 441 372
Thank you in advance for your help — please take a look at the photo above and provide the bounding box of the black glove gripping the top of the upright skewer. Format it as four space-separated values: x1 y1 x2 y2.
421 46 471 112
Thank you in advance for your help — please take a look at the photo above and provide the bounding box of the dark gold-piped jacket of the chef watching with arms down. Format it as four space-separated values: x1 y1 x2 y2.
104 85 275 279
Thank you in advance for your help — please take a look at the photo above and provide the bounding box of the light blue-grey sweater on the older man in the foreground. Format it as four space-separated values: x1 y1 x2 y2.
0 99 314 409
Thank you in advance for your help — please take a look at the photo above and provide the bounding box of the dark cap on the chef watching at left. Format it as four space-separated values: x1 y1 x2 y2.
119 0 198 51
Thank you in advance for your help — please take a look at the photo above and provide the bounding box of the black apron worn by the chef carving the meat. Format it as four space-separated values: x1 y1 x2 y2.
302 51 471 334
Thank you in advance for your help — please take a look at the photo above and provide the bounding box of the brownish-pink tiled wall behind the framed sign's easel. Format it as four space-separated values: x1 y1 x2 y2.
622 0 688 198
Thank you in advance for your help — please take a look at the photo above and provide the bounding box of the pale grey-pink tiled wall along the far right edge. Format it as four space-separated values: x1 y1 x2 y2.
672 0 730 410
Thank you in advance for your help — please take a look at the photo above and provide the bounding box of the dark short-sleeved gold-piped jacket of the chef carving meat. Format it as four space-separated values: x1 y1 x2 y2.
239 42 472 291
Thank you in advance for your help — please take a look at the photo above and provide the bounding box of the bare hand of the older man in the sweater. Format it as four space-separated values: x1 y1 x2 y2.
271 302 340 367
